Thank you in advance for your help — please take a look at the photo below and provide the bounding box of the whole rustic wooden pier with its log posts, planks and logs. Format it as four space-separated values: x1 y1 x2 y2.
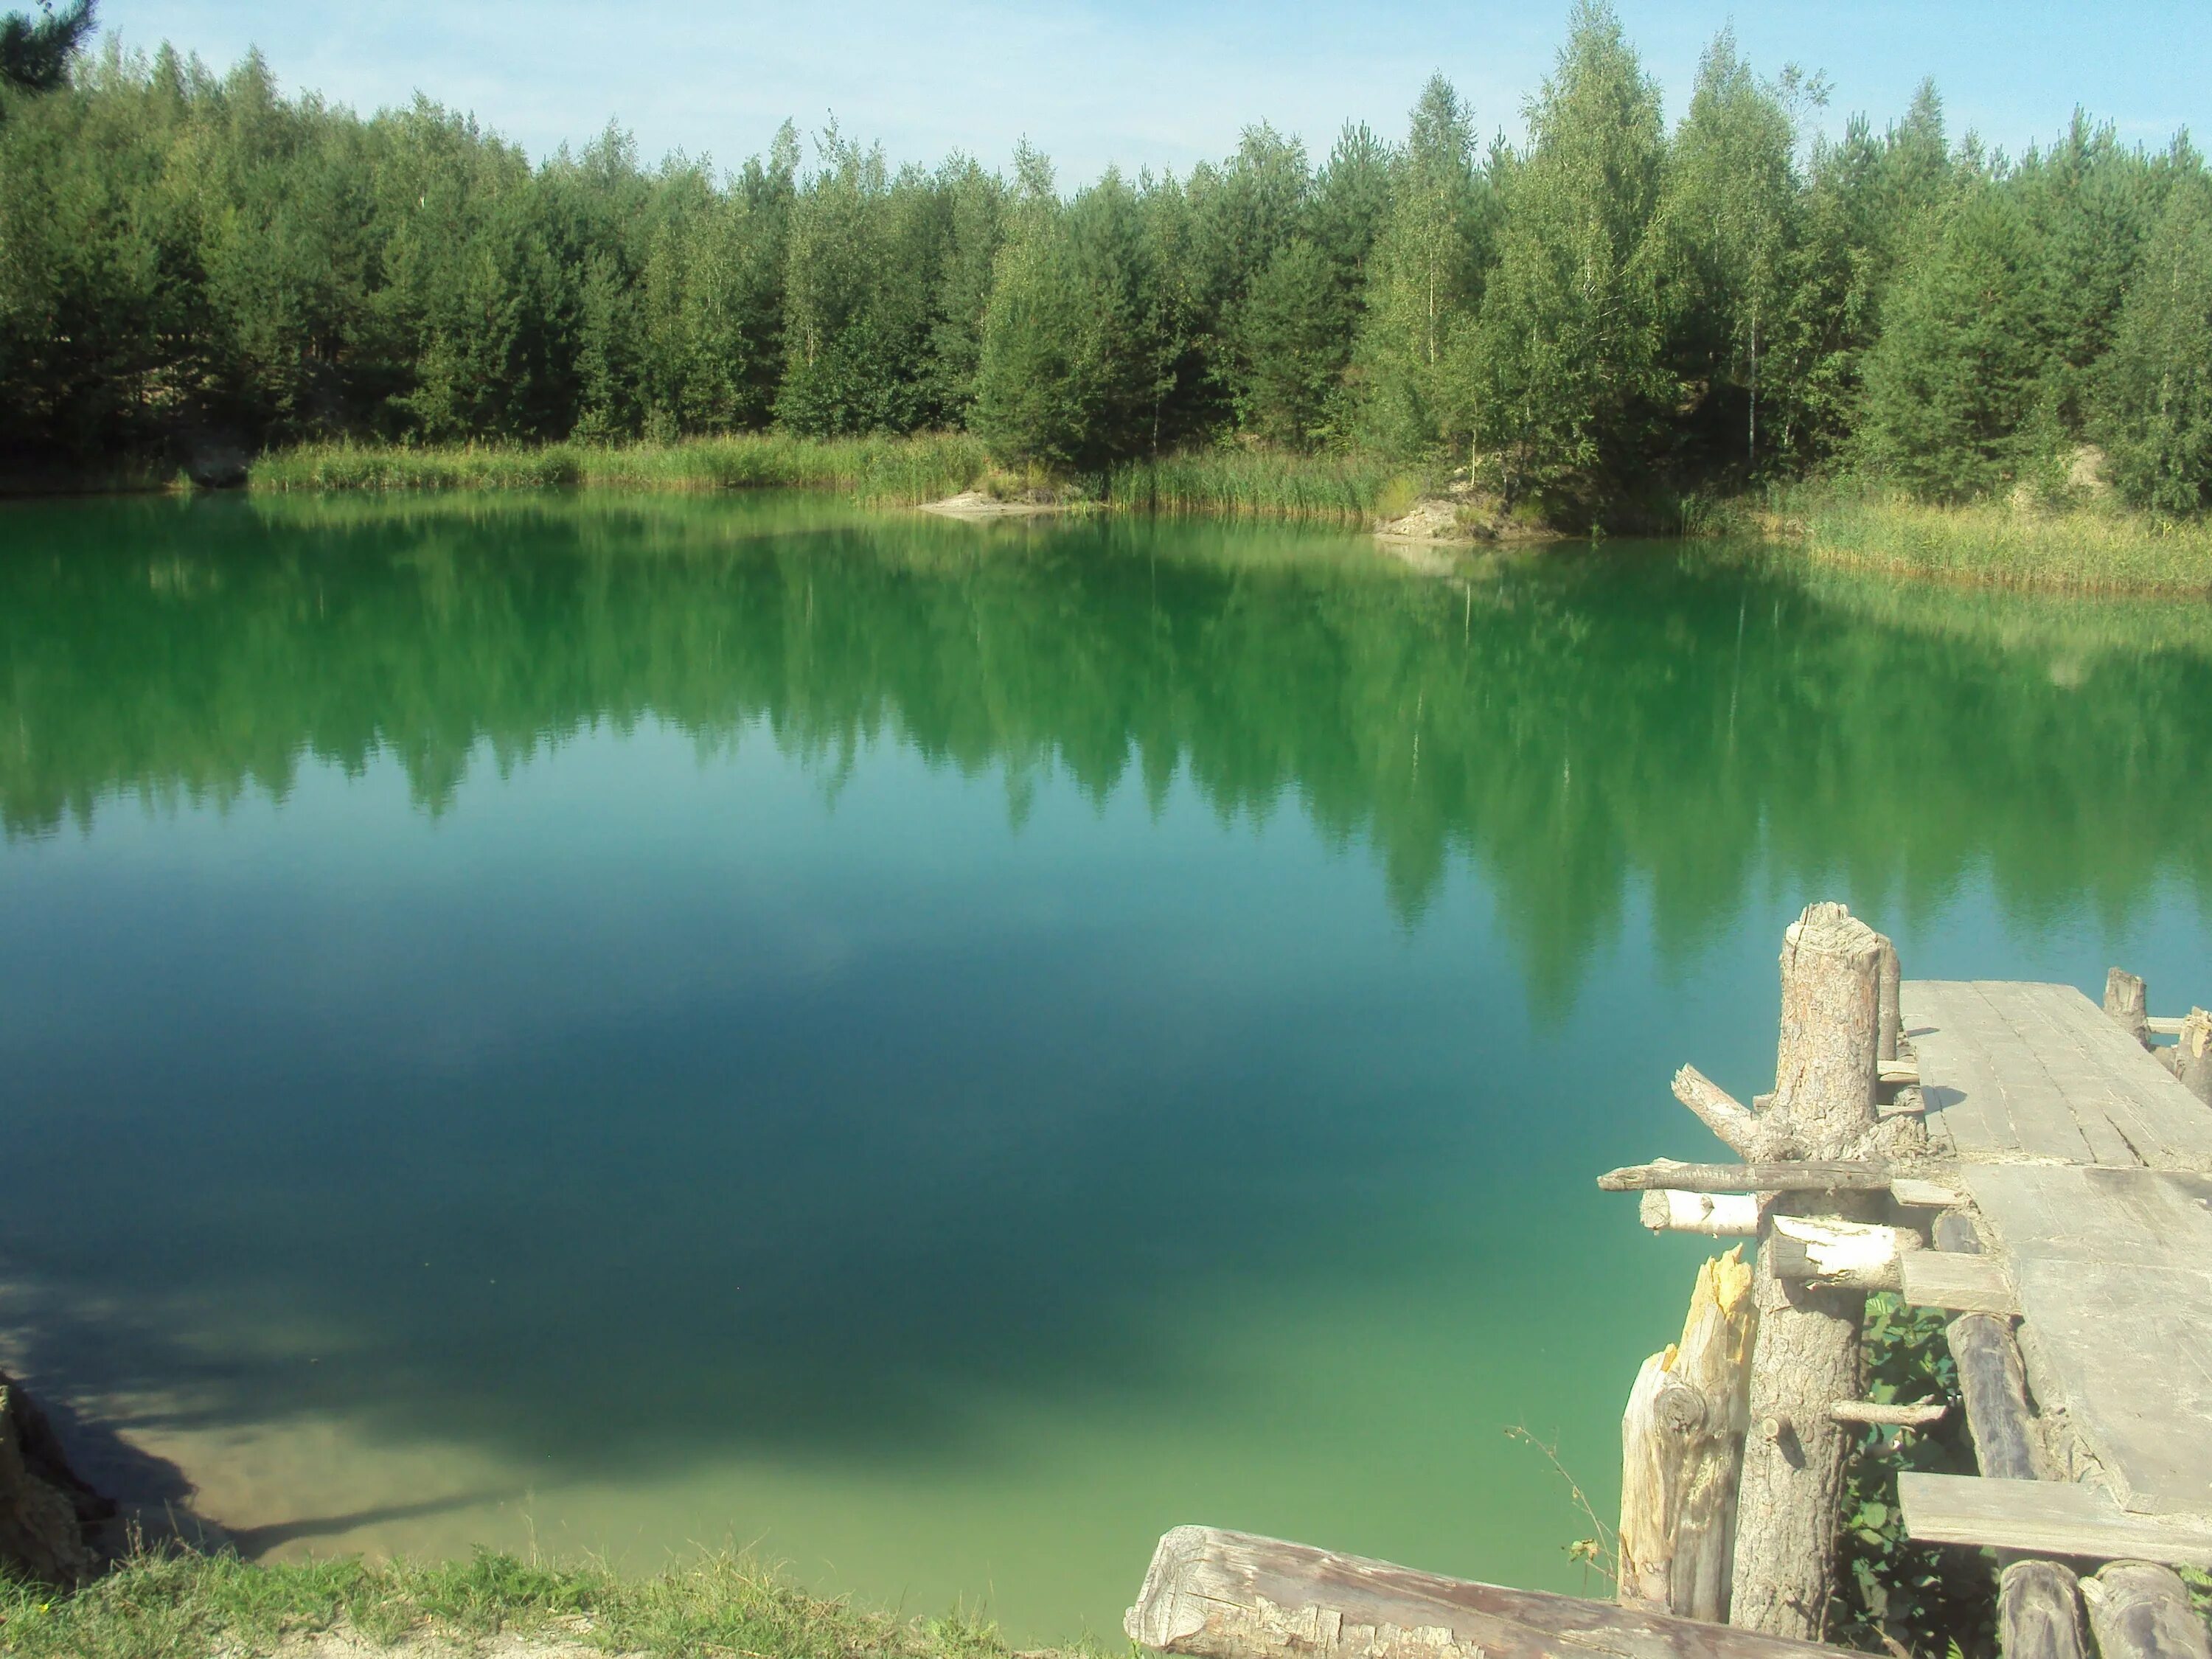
1126 905 2212 1659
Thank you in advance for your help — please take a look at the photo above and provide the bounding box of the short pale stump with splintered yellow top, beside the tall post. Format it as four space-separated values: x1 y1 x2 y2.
1619 1248 1752 1624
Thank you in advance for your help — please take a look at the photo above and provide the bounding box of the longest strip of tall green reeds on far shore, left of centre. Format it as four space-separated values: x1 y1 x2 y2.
248 431 984 504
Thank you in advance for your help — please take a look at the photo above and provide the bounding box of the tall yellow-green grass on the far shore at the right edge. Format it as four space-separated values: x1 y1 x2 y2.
1717 482 2212 593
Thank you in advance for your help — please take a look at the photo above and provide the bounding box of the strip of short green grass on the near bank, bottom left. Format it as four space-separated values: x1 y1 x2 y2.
0 1553 1084 1659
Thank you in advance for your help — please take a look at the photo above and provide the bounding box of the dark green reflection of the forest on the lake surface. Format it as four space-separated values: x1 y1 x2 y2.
0 495 2212 1002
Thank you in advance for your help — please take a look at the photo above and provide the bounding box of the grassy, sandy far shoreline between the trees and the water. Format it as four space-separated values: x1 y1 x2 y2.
13 434 2212 599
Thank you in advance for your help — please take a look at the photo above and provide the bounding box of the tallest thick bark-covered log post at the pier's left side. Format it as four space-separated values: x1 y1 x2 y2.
1730 905 1885 1641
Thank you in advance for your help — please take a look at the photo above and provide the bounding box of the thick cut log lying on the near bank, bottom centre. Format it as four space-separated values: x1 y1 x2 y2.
1121 1526 1840 1659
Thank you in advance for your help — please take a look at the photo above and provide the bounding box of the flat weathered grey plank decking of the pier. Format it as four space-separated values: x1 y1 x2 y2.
1900 980 2212 1566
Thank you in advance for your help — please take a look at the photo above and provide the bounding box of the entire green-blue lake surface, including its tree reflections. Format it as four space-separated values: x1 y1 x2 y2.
0 495 2212 1641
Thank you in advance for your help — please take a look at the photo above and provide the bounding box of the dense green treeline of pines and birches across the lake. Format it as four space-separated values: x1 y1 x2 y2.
0 0 2212 513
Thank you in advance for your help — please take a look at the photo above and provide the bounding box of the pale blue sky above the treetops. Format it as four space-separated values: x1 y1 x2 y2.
102 0 2212 184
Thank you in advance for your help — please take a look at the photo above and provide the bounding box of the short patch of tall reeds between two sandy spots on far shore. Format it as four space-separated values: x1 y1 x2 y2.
1106 449 1436 524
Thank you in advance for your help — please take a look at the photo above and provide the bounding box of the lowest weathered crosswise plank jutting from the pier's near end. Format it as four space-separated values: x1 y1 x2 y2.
1898 1473 2212 1566
